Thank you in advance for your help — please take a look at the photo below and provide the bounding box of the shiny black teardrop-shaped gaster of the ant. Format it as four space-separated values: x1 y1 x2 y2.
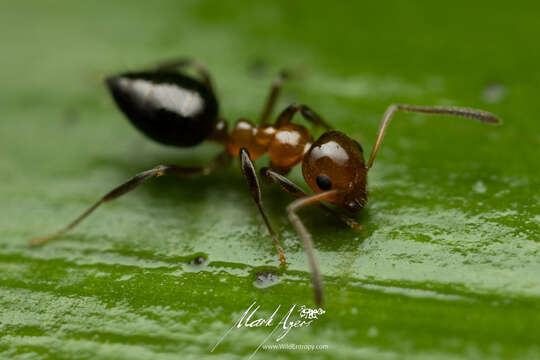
106 72 218 147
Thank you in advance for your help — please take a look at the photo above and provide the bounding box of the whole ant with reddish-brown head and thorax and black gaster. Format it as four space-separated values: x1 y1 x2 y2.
30 59 500 305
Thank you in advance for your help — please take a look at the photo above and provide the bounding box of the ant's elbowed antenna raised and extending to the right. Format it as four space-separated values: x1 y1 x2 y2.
366 104 501 170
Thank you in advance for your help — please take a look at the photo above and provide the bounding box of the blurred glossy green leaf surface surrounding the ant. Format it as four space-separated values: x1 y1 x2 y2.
0 1 540 359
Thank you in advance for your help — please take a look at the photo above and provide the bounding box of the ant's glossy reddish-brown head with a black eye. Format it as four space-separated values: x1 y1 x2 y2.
302 131 367 211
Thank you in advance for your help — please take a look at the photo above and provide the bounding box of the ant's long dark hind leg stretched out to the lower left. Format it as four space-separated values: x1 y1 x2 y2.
30 153 230 246
